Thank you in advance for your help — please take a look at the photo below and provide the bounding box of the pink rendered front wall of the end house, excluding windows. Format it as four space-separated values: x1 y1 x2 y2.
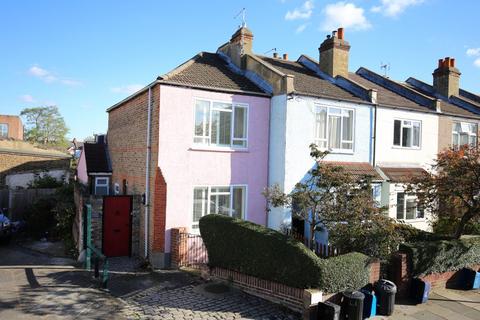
158 85 270 252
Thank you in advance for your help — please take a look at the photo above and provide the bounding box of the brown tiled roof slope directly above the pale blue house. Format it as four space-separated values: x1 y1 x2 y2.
257 55 365 102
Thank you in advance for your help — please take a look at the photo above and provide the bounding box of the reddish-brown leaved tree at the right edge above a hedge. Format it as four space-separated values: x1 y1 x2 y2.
407 145 480 239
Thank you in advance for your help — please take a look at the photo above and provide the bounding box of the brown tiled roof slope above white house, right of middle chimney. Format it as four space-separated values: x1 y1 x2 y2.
348 72 428 111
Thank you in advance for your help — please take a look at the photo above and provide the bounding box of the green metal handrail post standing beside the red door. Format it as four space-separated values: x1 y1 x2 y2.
85 204 109 288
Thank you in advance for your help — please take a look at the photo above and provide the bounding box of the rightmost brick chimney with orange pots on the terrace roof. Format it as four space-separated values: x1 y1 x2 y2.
433 57 461 98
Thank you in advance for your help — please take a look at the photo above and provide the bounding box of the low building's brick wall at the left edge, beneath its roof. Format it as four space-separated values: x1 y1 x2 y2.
0 151 70 186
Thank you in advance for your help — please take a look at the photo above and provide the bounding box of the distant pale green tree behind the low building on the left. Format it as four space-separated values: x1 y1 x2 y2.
20 106 68 146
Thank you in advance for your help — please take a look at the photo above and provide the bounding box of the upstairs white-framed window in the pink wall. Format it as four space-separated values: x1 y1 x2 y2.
193 100 248 148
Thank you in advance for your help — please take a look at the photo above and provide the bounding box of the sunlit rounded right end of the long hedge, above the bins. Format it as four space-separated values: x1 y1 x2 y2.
320 252 370 293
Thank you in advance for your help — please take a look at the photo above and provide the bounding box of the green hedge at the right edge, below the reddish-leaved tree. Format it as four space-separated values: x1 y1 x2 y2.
400 238 480 276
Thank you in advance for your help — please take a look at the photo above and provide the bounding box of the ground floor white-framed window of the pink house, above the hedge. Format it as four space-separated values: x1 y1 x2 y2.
192 185 247 229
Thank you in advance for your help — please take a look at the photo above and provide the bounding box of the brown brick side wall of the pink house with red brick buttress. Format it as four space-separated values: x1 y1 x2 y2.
107 85 165 264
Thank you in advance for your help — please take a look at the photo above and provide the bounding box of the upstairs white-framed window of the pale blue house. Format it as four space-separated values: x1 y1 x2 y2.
315 106 354 151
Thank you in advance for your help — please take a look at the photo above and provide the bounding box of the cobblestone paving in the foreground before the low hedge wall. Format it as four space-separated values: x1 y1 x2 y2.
124 284 300 320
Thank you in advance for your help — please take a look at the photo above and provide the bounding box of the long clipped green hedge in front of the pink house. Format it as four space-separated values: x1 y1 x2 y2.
200 214 369 292
